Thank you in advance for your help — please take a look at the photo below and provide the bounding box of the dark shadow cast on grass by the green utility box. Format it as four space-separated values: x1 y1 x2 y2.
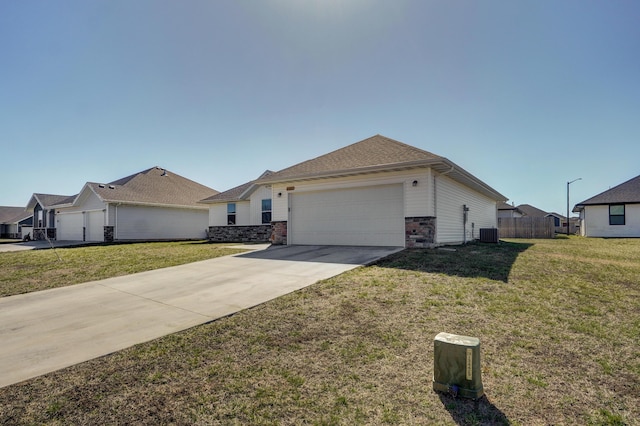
438 393 510 425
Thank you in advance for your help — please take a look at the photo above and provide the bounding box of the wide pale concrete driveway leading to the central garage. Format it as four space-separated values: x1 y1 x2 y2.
0 246 401 387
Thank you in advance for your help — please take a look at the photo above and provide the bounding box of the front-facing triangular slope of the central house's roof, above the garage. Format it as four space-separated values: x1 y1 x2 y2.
258 135 442 180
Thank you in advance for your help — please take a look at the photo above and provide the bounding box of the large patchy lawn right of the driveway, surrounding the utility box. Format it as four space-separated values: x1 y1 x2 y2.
0 237 640 425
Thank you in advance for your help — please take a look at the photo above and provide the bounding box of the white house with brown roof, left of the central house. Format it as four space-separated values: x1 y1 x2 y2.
54 167 217 242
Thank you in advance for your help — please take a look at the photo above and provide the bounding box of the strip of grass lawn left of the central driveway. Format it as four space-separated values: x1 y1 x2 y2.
0 241 242 297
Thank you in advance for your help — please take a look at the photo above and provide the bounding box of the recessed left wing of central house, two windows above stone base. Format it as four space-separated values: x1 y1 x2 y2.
201 170 273 242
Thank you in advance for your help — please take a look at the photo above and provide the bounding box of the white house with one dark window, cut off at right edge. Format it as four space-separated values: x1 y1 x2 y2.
573 176 640 237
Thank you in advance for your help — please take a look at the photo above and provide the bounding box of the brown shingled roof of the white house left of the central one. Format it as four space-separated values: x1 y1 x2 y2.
86 167 218 208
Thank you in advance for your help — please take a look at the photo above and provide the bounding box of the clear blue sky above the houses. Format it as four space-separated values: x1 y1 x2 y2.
0 0 640 213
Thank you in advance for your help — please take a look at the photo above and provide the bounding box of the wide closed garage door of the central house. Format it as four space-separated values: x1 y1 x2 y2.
289 185 405 247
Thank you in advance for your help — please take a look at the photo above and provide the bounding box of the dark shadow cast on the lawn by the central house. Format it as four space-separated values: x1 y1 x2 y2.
378 241 533 283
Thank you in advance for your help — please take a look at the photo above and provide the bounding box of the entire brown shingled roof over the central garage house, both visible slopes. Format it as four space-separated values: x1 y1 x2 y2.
256 135 507 201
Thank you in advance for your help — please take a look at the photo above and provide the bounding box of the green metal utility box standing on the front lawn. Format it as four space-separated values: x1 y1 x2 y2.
433 333 484 399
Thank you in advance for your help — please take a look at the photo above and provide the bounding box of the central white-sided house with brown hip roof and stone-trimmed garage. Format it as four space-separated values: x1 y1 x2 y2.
210 135 506 247
